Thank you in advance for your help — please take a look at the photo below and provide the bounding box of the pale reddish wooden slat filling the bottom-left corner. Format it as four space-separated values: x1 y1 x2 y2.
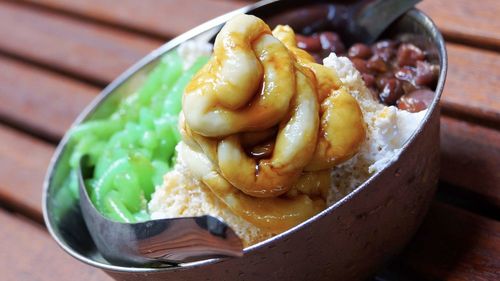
0 210 111 281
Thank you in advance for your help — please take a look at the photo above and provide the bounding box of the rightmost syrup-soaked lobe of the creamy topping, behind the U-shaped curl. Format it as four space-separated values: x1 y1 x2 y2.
273 25 365 171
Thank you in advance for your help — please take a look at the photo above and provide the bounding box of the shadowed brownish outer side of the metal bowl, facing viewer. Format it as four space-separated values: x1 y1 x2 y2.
107 10 447 280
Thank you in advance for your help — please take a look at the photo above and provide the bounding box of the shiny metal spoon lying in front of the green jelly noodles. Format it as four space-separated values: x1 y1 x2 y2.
78 158 243 266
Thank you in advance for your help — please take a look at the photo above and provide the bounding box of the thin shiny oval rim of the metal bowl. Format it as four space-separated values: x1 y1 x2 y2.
42 0 448 273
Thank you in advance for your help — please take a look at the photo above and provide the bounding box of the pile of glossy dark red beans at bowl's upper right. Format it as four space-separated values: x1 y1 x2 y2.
297 31 439 112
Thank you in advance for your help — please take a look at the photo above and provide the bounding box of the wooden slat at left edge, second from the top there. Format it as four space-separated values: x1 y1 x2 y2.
0 53 99 141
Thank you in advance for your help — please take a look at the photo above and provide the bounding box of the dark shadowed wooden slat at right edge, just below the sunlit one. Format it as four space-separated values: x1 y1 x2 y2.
441 118 500 206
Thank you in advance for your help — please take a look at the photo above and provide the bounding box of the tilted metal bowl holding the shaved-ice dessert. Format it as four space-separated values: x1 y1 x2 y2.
42 0 447 280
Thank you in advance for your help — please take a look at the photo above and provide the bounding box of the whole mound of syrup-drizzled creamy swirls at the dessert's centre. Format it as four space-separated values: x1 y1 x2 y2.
180 15 365 233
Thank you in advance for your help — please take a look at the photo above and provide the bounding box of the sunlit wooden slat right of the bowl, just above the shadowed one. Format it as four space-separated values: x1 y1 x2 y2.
442 43 500 124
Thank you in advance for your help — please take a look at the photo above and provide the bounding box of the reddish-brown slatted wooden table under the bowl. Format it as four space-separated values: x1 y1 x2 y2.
0 0 500 280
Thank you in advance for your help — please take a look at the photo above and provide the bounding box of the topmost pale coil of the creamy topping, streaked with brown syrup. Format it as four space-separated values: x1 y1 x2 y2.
183 15 296 137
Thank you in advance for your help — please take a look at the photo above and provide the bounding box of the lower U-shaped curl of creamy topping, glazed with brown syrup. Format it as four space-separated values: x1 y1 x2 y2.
217 66 319 197
